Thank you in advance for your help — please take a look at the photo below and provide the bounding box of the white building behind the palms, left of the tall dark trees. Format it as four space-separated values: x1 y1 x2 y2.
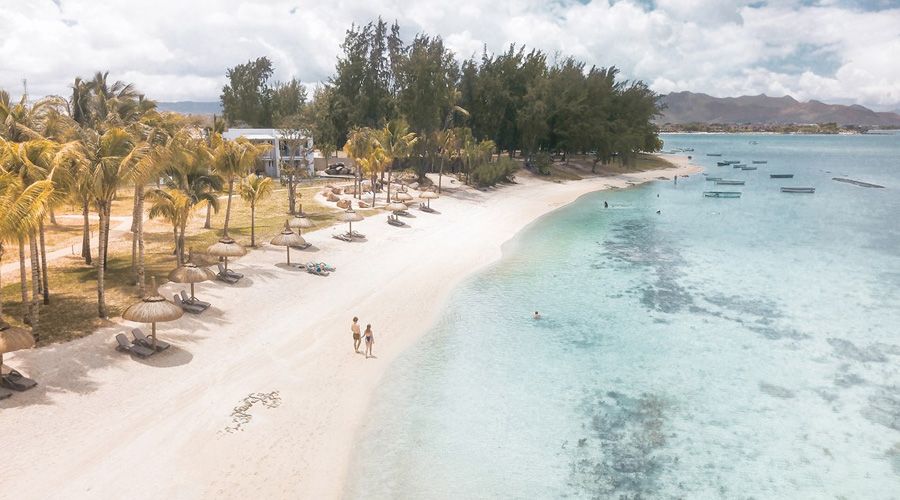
222 128 315 177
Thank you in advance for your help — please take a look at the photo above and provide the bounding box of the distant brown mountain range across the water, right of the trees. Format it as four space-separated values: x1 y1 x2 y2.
656 92 900 126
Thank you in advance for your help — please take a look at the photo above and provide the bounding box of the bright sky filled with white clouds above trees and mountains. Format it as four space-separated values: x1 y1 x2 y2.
0 0 900 110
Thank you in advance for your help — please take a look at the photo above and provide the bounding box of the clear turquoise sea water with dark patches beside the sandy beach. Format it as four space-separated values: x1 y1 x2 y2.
345 135 900 499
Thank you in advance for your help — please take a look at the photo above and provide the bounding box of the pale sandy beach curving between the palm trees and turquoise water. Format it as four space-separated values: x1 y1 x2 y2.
0 155 699 498
